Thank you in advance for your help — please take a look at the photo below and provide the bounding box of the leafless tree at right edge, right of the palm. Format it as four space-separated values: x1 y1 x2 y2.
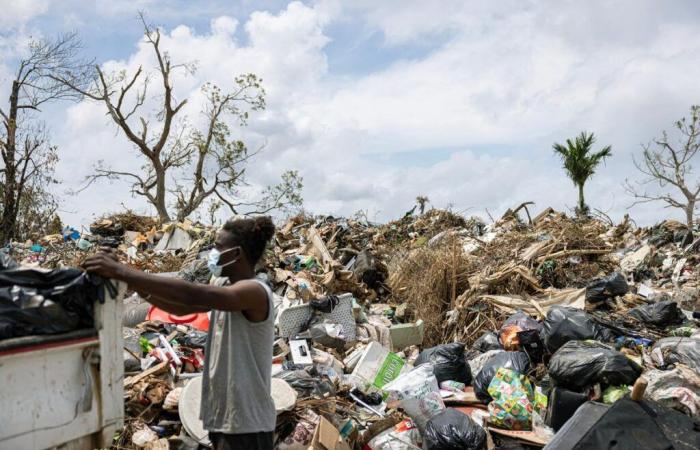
625 105 700 232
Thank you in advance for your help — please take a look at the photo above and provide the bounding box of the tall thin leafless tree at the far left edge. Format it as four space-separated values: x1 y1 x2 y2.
0 33 91 242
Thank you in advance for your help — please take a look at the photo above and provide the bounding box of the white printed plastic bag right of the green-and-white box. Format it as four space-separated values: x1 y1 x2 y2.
384 364 445 429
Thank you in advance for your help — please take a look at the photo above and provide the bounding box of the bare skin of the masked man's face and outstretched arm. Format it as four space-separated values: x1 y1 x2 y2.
83 230 268 322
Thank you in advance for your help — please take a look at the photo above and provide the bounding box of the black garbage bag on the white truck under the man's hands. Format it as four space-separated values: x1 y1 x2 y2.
0 269 116 339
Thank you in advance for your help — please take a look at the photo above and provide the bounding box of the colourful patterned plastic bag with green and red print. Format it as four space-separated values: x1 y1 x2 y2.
488 368 535 431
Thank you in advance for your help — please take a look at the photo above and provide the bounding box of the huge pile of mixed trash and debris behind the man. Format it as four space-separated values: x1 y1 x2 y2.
4 204 700 450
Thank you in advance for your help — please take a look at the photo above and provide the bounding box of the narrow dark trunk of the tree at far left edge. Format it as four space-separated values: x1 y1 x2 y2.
0 80 20 244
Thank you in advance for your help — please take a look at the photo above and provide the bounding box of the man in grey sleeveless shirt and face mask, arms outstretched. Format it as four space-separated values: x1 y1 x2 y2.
83 217 276 450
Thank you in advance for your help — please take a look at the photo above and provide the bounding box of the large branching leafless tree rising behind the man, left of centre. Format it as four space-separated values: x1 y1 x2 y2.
56 16 302 222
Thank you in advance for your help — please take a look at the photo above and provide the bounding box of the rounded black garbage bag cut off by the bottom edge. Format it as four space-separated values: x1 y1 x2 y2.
423 408 486 450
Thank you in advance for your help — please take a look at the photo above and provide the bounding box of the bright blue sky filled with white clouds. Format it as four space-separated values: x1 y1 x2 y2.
0 0 700 224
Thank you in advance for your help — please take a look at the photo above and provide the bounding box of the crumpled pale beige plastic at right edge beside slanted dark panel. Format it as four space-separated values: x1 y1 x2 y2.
643 364 700 419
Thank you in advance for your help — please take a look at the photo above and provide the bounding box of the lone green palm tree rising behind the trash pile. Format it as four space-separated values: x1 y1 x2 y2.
552 131 612 215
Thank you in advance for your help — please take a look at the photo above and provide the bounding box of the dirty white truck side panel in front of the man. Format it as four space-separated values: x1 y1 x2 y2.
0 286 124 450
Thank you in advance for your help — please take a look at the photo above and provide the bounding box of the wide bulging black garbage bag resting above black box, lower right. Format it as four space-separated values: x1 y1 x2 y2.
548 341 642 391
